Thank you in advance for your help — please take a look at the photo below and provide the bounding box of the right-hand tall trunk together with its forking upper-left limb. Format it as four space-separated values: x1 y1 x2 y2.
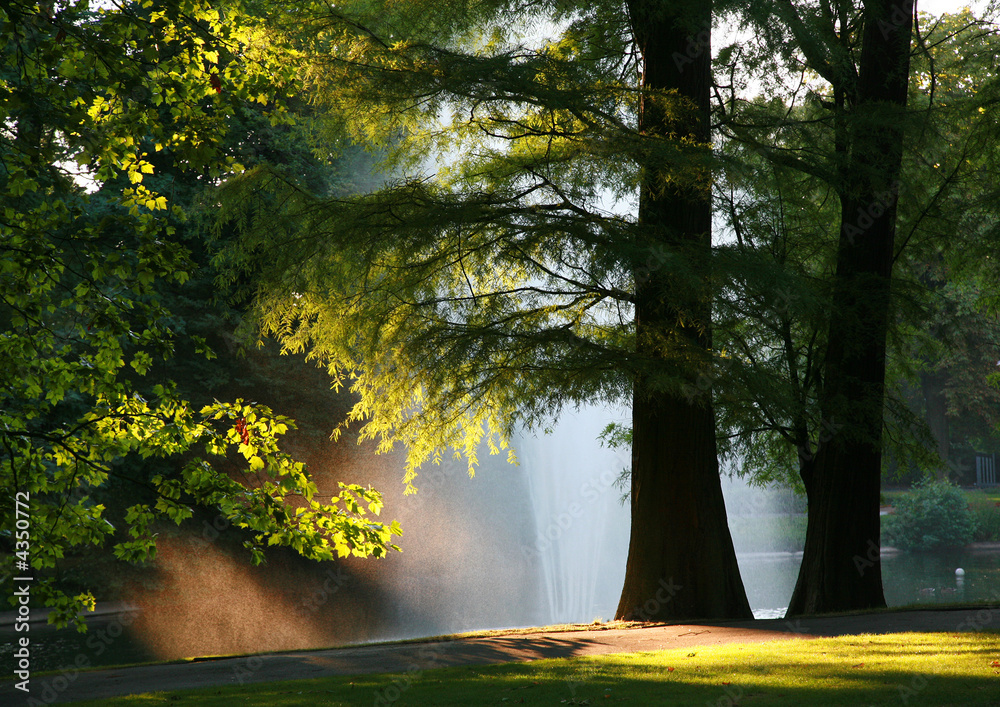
712 0 912 614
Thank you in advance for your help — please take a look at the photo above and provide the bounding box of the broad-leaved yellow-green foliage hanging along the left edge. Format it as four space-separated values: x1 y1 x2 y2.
0 1 399 622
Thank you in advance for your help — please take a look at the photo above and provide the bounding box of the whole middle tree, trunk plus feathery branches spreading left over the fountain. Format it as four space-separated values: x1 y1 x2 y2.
220 2 749 619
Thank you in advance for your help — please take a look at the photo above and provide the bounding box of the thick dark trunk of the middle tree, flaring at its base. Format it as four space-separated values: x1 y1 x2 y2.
616 0 752 621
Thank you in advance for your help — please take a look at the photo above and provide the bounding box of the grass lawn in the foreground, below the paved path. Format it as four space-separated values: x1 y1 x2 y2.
72 633 1000 707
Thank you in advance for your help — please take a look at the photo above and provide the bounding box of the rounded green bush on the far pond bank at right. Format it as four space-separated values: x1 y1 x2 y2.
882 481 976 550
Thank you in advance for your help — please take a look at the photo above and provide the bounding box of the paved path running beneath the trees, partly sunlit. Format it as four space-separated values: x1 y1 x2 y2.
0 608 1000 706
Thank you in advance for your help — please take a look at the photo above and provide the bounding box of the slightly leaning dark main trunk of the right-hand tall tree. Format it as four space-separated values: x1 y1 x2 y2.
788 0 913 615
